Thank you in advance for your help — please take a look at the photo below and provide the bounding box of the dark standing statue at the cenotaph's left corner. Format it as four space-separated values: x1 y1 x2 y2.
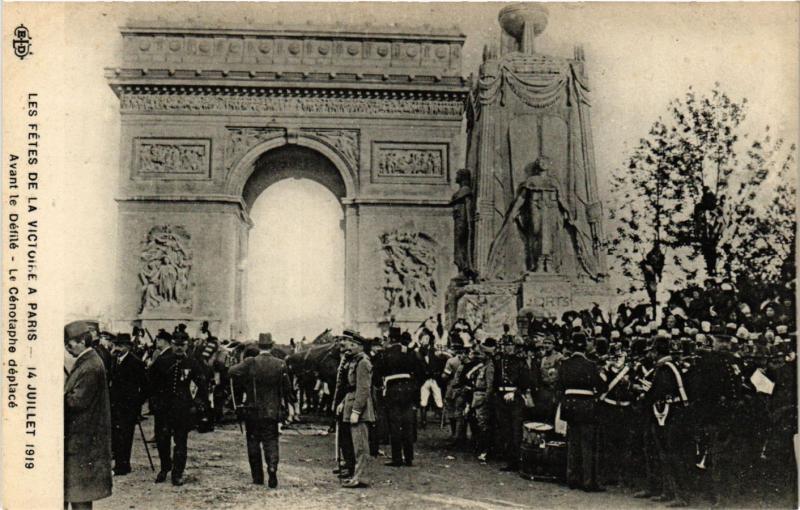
450 168 475 279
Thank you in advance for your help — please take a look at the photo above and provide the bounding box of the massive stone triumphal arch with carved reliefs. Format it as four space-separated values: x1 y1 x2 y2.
107 22 469 338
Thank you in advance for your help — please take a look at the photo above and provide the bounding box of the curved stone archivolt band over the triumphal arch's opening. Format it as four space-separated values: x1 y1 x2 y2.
226 133 358 199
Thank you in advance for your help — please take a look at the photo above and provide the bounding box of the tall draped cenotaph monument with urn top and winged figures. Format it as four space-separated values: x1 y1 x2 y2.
448 4 608 330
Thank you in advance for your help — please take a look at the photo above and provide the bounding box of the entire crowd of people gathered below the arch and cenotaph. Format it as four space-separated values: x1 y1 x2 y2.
65 281 797 508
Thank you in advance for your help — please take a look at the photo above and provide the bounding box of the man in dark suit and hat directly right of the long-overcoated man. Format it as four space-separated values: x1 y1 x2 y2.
111 333 146 476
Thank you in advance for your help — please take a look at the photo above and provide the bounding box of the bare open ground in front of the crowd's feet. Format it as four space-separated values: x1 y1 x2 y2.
95 418 792 510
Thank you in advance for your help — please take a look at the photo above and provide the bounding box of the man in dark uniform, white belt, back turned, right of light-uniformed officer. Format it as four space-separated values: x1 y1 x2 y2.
375 327 423 467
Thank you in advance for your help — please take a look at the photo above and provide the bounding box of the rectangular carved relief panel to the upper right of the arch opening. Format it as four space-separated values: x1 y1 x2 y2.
372 142 449 184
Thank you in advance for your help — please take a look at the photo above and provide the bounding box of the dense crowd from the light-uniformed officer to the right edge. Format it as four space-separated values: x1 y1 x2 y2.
328 280 797 507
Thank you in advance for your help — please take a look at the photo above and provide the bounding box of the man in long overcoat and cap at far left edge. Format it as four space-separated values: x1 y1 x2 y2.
64 321 111 509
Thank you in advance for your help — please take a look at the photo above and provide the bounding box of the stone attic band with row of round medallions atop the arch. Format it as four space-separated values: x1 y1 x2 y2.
121 23 465 77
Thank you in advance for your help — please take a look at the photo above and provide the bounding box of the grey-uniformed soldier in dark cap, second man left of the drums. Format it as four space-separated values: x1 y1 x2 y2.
465 338 497 462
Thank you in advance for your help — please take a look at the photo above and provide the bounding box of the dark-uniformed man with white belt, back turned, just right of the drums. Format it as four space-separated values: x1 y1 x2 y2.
558 333 606 492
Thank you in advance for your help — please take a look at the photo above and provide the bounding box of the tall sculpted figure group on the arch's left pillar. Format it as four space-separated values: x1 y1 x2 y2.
139 225 192 312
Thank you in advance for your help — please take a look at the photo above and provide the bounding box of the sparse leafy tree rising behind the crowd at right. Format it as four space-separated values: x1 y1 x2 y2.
611 84 796 299
